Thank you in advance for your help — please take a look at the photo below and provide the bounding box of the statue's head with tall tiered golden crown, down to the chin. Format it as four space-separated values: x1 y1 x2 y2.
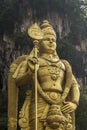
40 20 56 54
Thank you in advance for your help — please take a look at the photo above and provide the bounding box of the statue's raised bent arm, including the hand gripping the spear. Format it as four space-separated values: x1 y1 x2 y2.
13 56 37 86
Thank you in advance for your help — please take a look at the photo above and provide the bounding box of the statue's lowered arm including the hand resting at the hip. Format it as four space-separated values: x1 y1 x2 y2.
62 61 80 113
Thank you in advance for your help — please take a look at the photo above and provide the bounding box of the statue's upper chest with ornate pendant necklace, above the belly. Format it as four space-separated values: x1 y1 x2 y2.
38 60 65 80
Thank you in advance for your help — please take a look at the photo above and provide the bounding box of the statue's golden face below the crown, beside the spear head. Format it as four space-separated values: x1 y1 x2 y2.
40 35 56 54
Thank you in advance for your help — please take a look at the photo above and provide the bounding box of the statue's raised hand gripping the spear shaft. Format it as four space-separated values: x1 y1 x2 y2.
27 57 39 71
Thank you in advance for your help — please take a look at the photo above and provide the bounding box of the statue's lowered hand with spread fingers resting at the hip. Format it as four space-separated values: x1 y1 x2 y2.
61 102 77 113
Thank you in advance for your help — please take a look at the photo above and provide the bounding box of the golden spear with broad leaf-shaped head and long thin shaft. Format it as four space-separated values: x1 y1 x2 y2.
28 23 43 130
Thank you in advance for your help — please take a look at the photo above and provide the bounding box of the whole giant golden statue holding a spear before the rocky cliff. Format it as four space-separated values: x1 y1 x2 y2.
8 20 80 130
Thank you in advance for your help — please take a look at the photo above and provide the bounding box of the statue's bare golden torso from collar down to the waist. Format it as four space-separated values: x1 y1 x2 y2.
38 59 65 92
